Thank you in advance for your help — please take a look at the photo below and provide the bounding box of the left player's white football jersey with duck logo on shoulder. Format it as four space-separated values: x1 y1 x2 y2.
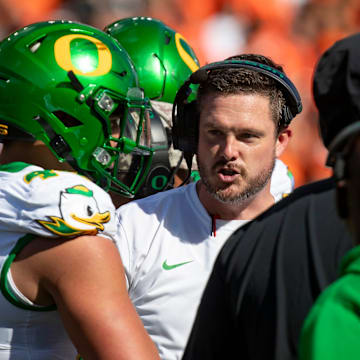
0 162 116 360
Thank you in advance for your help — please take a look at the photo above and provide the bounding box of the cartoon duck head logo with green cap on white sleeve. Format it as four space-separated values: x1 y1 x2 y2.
37 185 111 236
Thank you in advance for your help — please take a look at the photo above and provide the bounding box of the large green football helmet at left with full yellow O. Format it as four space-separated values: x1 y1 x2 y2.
0 20 153 197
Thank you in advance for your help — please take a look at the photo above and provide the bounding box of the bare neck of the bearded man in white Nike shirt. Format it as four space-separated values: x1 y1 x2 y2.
196 181 275 220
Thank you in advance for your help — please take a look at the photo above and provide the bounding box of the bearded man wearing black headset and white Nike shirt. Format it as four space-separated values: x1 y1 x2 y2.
117 54 301 360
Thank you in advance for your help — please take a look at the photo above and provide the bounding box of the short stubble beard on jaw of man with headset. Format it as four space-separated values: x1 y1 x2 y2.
197 155 276 205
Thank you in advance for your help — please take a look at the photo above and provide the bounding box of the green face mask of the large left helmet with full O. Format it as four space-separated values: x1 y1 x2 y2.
93 88 154 197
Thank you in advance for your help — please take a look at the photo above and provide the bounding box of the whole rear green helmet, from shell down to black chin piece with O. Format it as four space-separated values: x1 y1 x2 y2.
104 17 199 197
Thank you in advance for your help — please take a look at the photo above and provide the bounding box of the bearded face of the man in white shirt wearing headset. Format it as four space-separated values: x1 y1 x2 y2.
197 93 288 203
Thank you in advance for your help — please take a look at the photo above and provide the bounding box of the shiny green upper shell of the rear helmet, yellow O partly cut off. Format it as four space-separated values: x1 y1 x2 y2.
104 17 199 104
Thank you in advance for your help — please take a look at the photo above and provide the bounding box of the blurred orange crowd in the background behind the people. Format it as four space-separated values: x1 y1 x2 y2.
0 0 360 186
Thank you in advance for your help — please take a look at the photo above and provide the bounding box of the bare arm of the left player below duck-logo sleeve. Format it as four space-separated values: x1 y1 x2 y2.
14 236 159 360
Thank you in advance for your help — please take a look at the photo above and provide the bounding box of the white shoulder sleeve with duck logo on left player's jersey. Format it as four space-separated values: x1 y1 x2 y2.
0 166 116 239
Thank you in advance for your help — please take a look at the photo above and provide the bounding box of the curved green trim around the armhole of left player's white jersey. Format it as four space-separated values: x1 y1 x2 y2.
0 234 56 311
